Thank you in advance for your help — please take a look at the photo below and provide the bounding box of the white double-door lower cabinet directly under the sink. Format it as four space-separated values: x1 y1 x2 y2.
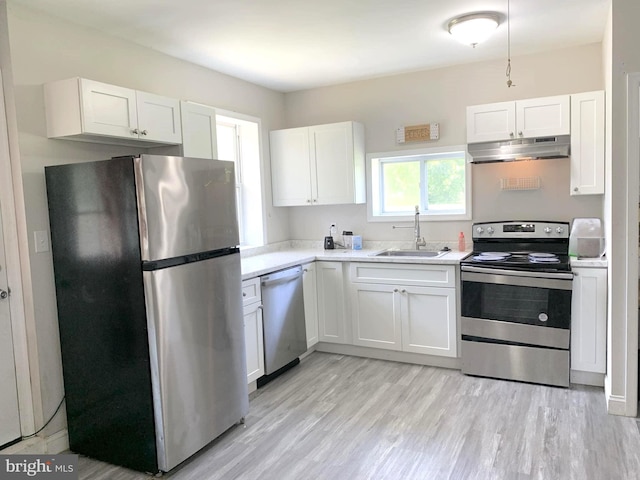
351 263 457 357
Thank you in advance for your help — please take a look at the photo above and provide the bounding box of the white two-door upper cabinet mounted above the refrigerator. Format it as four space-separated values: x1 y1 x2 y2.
44 78 182 146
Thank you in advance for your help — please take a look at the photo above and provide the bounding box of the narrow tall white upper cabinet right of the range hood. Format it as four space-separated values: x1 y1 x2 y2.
570 91 605 195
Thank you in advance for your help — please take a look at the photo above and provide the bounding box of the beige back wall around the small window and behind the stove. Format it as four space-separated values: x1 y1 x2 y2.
285 44 604 242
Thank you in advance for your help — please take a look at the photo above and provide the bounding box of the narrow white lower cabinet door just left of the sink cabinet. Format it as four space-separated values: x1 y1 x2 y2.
316 262 349 343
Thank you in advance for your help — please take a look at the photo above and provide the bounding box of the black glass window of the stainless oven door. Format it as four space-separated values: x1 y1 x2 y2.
461 280 571 328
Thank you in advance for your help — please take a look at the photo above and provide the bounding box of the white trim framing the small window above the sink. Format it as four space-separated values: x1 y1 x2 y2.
365 145 472 222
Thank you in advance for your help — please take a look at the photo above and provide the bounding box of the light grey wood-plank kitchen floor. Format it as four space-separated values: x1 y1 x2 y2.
79 352 640 480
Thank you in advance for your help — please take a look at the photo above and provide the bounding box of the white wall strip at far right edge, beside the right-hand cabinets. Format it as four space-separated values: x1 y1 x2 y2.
605 0 640 416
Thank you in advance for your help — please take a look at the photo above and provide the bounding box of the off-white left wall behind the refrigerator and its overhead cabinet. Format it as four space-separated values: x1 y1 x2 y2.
8 4 289 433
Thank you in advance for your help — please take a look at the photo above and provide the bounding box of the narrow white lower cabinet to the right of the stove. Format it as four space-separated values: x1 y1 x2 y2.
571 268 607 373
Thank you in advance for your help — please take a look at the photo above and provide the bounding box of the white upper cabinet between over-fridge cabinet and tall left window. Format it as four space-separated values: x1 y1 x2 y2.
180 102 218 159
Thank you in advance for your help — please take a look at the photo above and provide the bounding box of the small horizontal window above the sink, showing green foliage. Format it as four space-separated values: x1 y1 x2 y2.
367 146 471 221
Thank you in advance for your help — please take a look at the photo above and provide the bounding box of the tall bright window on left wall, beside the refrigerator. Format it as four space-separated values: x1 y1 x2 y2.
216 110 264 247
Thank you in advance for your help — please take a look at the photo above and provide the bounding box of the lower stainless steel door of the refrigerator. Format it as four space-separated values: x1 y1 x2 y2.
143 254 249 471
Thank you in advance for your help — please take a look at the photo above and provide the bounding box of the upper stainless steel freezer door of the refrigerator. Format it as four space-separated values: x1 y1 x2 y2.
134 155 239 261
